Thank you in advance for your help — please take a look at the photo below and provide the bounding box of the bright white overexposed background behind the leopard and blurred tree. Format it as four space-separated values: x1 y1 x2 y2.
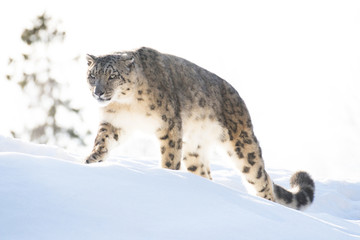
0 0 360 181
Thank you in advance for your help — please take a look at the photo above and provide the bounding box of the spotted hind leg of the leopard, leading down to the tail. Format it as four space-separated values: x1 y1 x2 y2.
220 83 275 201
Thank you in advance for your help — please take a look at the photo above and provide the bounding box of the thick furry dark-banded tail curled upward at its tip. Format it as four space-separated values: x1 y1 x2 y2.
274 172 315 210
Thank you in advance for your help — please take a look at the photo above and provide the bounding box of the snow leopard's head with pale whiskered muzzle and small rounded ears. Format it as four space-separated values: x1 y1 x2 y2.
87 53 136 106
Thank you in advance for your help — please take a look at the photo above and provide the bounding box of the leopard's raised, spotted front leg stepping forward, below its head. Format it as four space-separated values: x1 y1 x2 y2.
85 122 121 163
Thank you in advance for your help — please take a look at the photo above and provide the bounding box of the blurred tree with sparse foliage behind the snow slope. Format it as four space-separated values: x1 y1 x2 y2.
6 13 90 147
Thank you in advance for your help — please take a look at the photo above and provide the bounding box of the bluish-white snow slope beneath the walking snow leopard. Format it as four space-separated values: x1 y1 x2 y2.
0 136 360 240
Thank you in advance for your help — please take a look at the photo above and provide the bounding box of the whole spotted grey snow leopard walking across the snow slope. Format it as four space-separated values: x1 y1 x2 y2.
85 47 315 209
